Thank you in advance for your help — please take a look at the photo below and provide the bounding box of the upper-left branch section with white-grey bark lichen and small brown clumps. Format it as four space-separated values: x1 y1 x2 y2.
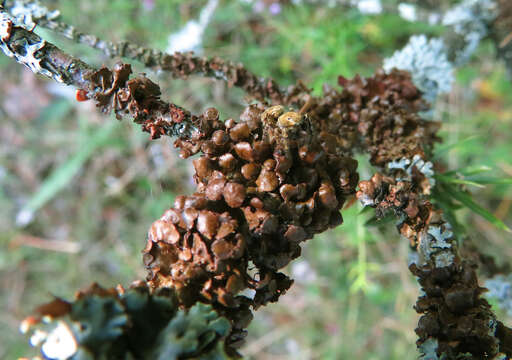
0 5 206 138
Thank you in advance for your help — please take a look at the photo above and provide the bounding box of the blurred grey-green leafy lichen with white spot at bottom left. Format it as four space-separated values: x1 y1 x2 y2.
22 283 230 360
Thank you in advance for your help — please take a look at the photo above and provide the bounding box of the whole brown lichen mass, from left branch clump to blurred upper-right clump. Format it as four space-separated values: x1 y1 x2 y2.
79 65 435 343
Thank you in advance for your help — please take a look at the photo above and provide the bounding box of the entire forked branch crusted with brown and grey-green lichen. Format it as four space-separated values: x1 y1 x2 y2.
4 9 512 359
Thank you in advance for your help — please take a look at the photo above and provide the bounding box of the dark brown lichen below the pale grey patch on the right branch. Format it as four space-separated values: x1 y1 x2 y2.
411 259 506 359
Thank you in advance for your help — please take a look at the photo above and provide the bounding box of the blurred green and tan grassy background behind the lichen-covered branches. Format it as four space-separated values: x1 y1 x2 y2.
0 0 512 359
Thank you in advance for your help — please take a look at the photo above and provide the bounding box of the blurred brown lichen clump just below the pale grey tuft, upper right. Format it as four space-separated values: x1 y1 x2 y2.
312 70 439 167
